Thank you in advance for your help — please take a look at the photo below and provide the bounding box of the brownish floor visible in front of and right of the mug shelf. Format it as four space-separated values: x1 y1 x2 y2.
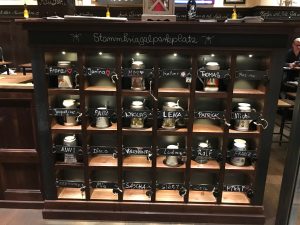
0 123 290 225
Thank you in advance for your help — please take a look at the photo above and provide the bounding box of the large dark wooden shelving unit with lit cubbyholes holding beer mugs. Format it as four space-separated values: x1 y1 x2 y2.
24 20 291 224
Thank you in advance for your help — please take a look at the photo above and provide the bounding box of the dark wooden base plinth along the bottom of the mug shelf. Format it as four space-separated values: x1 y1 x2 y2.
43 201 265 225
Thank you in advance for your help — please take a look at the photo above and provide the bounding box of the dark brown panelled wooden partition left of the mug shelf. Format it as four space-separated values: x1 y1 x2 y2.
0 89 43 208
